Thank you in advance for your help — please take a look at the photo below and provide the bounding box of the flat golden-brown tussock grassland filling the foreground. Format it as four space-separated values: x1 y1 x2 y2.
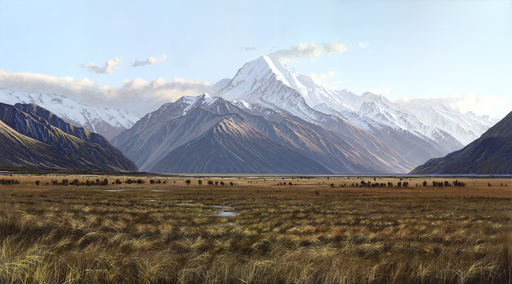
0 172 512 283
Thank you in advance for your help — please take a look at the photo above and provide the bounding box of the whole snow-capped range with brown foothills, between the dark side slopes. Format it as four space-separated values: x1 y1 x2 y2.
0 56 497 174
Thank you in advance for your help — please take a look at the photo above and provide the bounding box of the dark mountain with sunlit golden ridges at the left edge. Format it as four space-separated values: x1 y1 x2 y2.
0 103 137 172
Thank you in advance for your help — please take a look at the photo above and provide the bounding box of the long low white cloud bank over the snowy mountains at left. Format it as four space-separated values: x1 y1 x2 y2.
0 69 212 117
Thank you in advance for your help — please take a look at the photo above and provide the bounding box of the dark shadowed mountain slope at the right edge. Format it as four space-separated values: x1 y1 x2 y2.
411 112 512 174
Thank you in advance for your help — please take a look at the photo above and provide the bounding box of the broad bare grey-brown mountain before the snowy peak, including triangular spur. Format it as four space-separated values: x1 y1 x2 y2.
112 94 414 174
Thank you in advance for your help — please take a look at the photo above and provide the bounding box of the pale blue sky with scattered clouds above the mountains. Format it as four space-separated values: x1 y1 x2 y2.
0 0 512 118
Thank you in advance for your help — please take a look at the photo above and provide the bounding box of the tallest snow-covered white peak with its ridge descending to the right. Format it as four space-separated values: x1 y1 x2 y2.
215 56 472 165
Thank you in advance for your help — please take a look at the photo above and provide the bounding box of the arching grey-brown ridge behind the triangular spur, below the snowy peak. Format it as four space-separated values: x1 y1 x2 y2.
112 95 414 174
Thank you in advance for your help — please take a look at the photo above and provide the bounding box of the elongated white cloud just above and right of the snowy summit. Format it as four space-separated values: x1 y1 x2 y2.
268 42 348 61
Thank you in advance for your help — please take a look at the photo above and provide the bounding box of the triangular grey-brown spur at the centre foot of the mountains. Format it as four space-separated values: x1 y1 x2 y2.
151 116 331 174
